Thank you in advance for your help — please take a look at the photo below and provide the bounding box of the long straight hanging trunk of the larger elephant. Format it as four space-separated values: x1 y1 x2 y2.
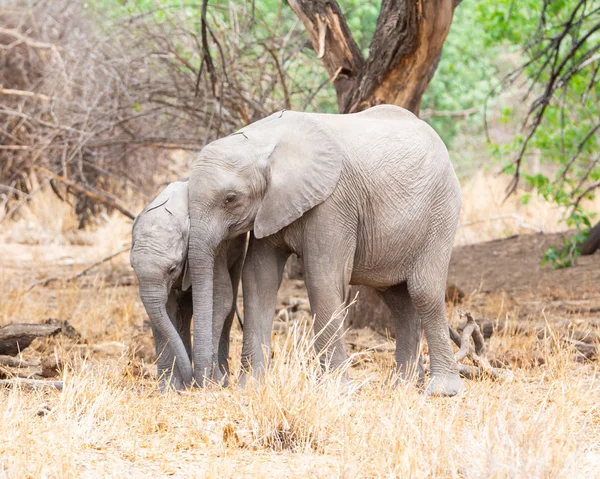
188 225 216 386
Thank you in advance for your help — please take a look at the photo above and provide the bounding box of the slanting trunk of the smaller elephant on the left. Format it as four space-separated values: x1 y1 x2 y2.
140 285 192 386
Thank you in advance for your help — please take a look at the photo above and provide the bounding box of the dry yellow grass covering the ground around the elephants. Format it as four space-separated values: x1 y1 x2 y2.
0 176 600 478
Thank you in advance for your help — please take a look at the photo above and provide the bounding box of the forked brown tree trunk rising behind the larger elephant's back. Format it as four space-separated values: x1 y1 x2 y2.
288 0 460 114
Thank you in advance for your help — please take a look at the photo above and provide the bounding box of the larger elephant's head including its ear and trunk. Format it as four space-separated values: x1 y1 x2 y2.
189 111 343 380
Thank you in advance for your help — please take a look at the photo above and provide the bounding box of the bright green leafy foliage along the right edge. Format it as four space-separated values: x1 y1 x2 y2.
477 0 600 267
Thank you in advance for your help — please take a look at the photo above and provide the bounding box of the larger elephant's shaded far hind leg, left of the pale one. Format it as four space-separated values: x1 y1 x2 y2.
379 283 424 382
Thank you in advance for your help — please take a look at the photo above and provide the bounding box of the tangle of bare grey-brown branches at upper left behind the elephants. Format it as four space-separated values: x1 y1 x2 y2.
0 0 310 224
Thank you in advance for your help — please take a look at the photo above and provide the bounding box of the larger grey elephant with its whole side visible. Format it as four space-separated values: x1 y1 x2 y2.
189 105 463 396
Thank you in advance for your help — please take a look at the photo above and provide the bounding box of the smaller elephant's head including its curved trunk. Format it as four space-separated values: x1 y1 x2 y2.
130 180 192 384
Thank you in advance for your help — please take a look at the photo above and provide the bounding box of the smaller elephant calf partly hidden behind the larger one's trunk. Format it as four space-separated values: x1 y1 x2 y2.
130 179 246 391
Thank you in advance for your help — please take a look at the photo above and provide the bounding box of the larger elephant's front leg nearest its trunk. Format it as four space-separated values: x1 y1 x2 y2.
241 235 289 385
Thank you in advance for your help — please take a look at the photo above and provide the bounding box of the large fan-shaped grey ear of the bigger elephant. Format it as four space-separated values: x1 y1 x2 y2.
253 112 344 238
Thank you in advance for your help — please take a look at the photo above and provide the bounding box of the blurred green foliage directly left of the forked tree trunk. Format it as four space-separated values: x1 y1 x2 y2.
96 0 336 113
